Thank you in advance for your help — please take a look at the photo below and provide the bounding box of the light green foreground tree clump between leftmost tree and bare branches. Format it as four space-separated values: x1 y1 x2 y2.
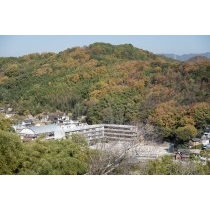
19 134 89 175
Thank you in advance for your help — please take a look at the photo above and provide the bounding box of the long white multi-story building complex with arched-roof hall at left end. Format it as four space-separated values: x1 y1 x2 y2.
19 124 138 141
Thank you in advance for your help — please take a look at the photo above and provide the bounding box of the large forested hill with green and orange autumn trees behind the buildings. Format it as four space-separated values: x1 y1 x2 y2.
0 43 210 141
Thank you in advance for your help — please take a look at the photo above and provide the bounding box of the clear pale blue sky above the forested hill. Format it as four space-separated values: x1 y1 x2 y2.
0 35 210 57
